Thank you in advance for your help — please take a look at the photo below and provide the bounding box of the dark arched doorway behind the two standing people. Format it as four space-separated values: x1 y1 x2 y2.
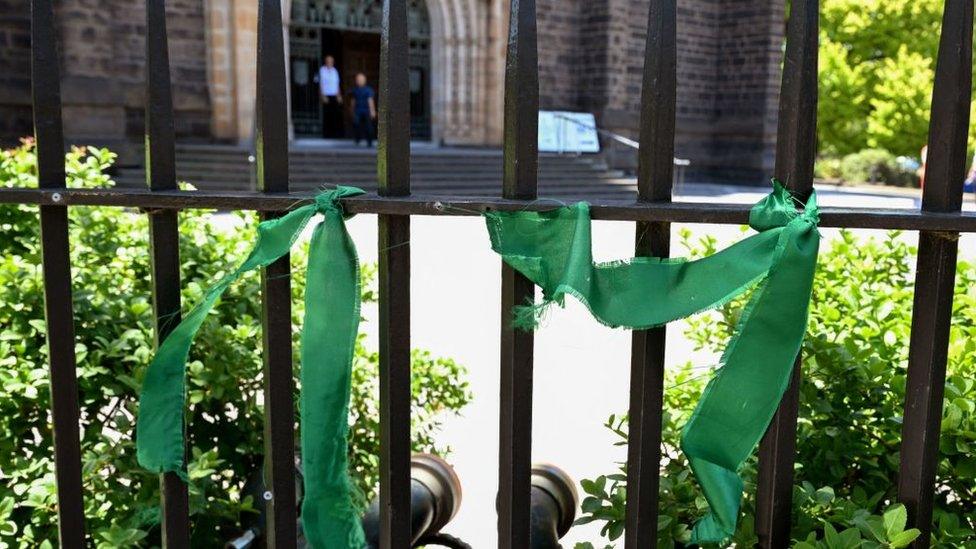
289 0 431 139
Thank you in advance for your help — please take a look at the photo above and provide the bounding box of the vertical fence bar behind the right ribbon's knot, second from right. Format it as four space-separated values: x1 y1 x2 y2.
756 0 820 548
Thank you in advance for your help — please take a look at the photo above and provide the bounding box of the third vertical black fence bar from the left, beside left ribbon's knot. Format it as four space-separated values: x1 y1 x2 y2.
255 0 297 547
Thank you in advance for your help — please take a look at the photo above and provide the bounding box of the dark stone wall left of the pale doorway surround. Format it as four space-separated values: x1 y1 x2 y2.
0 0 211 162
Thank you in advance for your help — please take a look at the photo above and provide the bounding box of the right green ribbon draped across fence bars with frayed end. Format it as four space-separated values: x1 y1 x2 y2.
485 180 820 543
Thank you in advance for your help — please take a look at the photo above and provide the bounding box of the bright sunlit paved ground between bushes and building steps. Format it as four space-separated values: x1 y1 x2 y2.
210 181 976 548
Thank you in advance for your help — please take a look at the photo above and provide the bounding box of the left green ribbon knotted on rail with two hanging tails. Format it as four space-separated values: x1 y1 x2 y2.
136 187 365 549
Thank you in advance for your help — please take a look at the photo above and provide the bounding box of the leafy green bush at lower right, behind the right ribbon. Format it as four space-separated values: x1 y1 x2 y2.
579 232 976 549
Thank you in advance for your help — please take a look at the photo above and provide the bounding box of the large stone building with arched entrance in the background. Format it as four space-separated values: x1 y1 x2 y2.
0 0 785 181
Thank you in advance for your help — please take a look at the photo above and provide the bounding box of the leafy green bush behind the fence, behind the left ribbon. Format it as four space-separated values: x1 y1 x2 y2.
0 143 471 547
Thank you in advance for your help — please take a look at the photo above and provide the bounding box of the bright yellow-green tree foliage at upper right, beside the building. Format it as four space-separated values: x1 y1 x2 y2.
817 0 972 157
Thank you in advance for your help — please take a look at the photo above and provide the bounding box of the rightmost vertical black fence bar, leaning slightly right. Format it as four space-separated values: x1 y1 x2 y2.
898 0 973 549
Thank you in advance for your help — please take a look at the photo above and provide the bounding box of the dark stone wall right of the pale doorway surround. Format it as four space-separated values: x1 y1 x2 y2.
539 0 785 183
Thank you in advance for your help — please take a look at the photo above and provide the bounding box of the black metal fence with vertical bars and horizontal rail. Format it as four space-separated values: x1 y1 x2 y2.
0 0 976 548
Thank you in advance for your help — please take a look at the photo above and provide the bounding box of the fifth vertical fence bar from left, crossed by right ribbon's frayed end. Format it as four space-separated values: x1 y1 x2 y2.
497 0 539 549
